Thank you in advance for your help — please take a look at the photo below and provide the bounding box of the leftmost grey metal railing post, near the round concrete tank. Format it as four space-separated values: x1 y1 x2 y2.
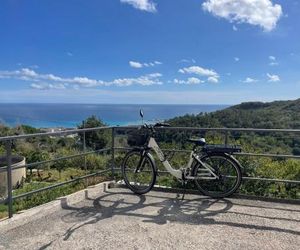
6 140 13 218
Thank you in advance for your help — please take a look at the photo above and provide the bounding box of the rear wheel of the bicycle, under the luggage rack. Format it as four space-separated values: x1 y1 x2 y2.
193 153 242 198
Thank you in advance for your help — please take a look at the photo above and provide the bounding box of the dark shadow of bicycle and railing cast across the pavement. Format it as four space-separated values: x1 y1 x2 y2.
57 190 299 240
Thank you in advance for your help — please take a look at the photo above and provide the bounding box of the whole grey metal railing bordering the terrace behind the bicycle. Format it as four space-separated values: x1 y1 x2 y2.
0 126 300 218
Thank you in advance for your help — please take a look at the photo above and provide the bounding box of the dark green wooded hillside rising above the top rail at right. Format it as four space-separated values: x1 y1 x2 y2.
168 99 300 129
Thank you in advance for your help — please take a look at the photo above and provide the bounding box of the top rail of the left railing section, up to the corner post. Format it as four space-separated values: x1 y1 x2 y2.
0 127 112 142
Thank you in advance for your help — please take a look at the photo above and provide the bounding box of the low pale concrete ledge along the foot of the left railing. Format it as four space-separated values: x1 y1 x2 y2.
0 181 112 229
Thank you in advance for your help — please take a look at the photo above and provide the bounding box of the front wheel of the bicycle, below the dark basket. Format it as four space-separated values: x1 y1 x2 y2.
122 150 156 194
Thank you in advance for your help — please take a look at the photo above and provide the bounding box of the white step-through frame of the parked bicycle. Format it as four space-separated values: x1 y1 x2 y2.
148 137 219 180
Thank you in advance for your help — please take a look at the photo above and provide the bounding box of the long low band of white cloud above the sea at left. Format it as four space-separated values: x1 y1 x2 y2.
0 68 162 89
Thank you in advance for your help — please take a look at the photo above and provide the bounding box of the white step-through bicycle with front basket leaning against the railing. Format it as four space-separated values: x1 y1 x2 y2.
121 113 242 198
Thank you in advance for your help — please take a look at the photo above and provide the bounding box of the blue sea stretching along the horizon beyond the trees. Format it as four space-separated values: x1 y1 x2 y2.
0 104 228 128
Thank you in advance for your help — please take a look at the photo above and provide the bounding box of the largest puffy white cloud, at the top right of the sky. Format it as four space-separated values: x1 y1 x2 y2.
202 0 282 31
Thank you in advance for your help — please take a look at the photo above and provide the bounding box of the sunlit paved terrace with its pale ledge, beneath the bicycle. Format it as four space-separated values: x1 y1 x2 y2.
0 183 300 250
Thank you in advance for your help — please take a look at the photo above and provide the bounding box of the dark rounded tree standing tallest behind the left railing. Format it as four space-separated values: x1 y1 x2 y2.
78 115 109 150
